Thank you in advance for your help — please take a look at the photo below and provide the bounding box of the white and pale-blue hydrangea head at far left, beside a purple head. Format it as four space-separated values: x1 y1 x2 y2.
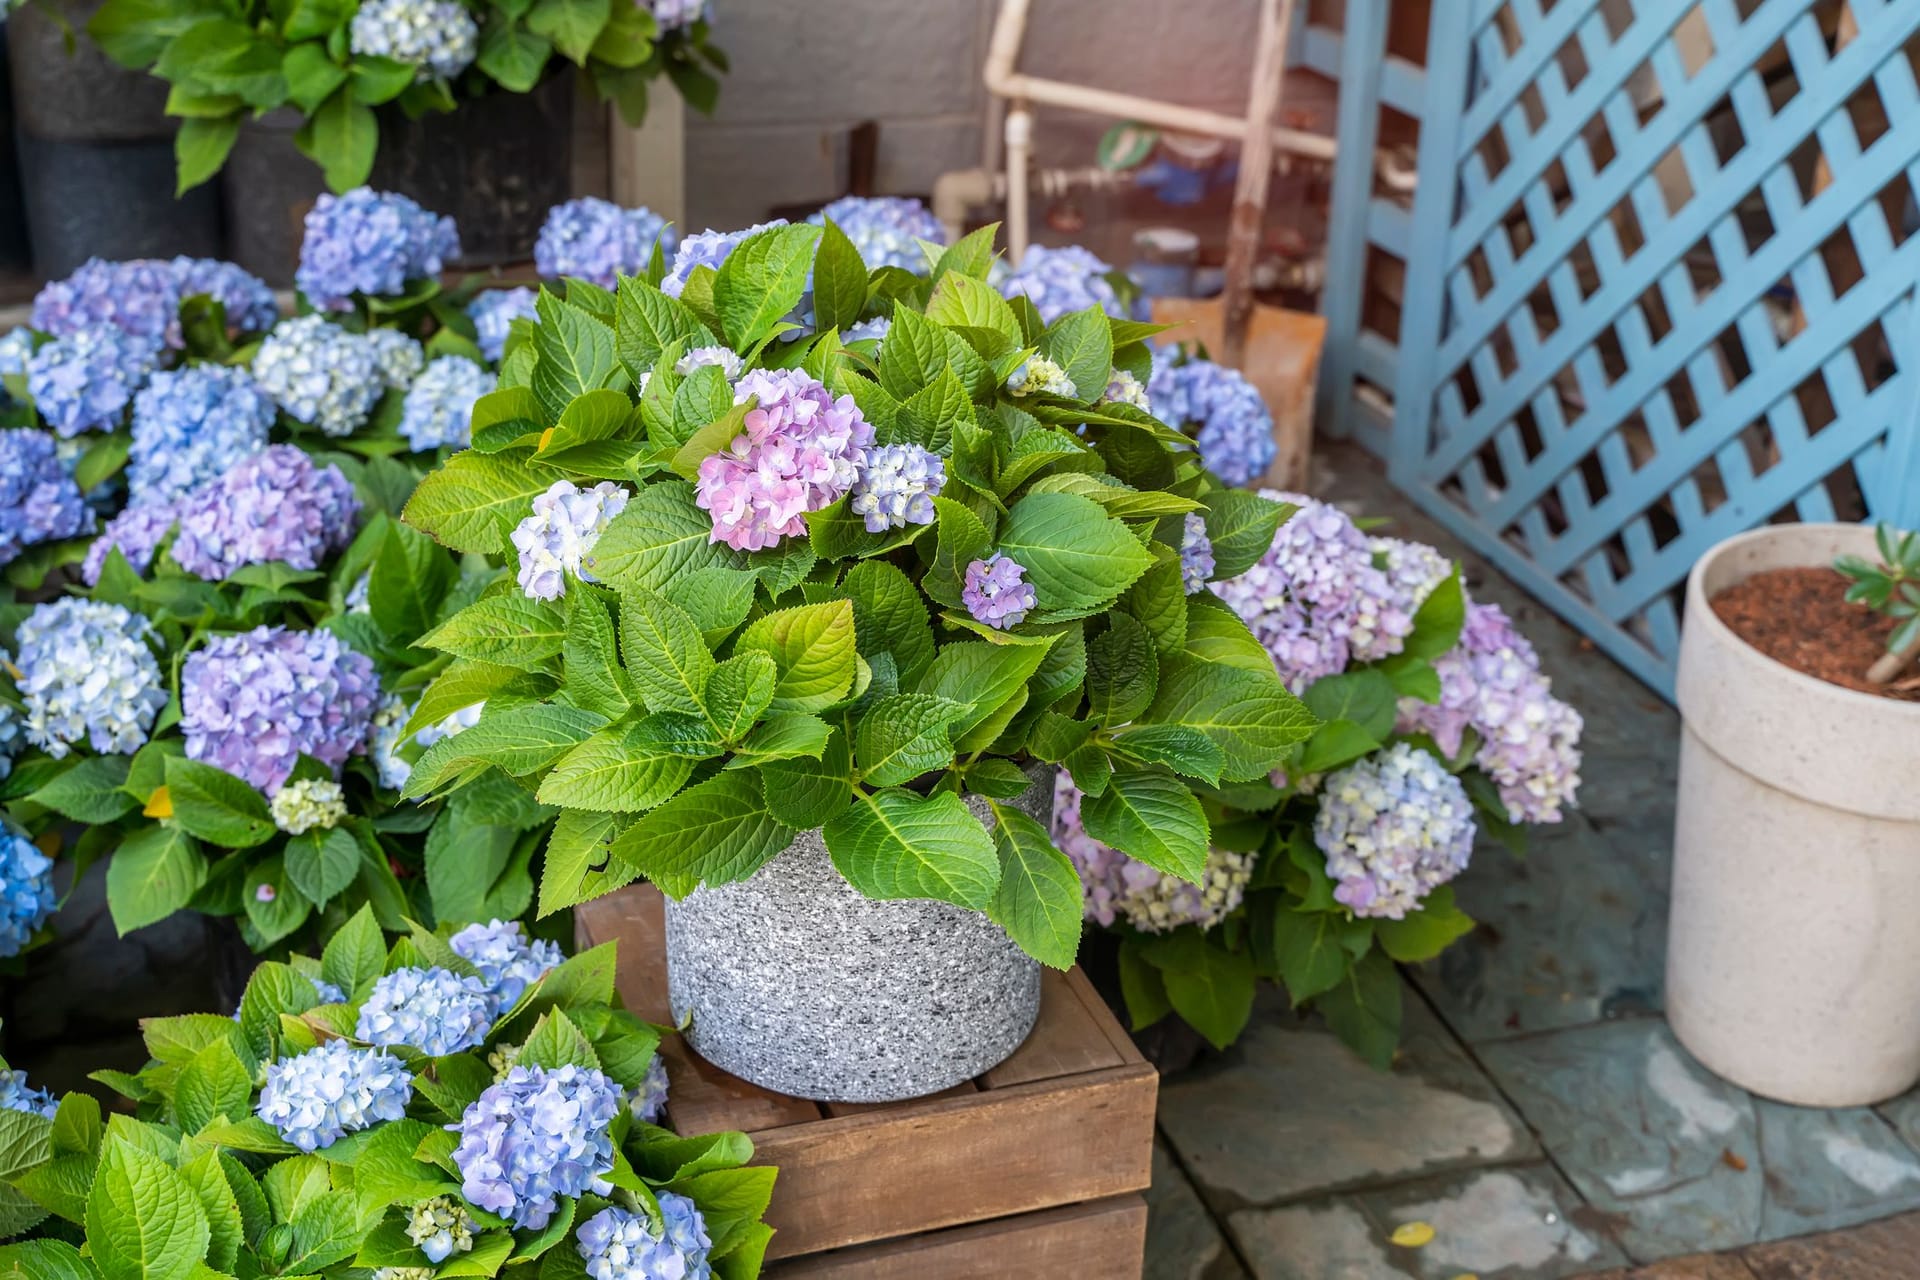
15 595 167 760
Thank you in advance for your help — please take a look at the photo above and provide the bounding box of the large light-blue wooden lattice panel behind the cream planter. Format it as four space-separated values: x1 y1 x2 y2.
1390 0 1920 691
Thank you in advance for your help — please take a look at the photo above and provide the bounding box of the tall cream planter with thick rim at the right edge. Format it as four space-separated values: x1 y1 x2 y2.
1667 524 1920 1107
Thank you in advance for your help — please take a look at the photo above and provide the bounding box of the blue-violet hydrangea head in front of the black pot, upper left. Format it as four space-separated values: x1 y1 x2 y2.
294 188 460 311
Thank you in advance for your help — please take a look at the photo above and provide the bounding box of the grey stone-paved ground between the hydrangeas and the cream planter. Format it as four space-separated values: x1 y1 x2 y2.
1148 449 1920 1280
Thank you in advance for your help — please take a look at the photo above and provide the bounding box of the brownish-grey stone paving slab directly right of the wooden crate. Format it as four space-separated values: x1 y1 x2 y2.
1160 992 1540 1213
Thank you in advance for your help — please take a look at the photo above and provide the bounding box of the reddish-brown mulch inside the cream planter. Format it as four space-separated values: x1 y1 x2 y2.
1713 568 1920 700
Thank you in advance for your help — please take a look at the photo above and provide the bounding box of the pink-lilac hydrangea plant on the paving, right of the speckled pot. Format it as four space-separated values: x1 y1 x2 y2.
1054 493 1582 1067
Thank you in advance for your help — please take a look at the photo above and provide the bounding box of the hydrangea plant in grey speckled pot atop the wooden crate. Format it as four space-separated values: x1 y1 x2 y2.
405 221 1313 1100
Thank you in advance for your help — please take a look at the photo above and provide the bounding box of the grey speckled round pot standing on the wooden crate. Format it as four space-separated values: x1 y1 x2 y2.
666 771 1052 1102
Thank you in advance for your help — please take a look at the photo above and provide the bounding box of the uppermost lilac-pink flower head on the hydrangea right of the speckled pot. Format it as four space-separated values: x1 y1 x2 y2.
1213 489 1413 693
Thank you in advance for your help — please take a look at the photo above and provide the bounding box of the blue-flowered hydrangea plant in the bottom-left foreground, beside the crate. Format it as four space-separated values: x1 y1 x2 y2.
0 912 776 1280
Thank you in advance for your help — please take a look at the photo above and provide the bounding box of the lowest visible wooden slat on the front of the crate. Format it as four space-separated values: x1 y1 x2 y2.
766 1196 1146 1280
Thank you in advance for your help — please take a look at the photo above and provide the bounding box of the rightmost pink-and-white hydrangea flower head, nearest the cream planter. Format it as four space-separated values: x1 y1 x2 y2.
1400 604 1584 823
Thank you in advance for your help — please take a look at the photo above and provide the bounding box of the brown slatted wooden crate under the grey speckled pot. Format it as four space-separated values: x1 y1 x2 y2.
576 885 1160 1280
